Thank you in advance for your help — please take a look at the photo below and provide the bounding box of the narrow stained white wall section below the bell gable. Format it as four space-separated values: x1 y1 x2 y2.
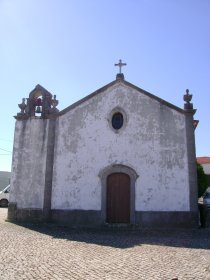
10 118 48 209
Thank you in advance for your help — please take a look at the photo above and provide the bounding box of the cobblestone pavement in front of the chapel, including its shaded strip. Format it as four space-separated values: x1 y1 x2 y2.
0 209 210 280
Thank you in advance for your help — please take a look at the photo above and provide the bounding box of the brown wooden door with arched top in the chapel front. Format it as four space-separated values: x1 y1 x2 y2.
107 173 130 223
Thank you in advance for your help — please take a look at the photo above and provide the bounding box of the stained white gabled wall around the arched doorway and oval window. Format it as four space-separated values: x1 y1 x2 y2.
52 82 189 211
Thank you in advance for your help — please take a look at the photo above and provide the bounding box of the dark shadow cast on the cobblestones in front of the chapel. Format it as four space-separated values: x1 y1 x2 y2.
7 223 210 249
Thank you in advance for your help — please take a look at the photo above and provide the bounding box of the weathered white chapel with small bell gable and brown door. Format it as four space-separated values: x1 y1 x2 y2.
8 73 198 227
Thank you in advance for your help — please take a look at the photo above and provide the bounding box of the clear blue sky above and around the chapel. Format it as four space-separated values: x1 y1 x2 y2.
0 0 210 171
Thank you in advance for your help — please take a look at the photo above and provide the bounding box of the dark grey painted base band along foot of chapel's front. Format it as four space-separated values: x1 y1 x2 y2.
8 204 199 229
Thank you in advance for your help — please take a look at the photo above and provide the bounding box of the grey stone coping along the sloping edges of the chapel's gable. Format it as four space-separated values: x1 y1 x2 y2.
59 79 185 115
